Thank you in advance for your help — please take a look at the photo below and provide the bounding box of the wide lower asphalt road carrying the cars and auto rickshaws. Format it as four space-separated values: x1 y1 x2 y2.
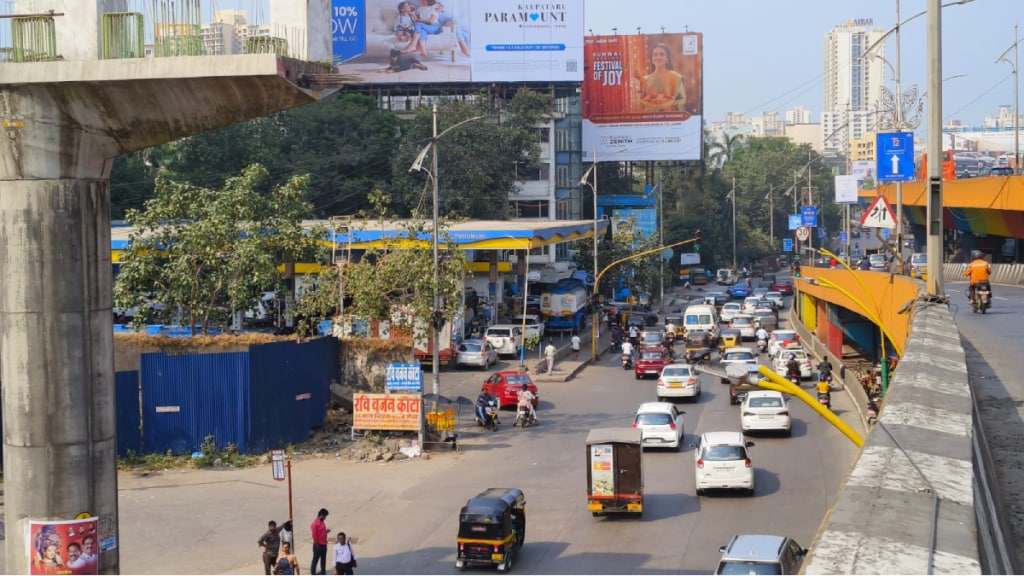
99 293 860 574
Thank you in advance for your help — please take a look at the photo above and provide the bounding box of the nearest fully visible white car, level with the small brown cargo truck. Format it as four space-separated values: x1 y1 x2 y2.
692 431 754 496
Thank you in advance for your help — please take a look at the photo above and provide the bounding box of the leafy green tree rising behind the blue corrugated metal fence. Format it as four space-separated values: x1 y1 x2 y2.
114 165 324 333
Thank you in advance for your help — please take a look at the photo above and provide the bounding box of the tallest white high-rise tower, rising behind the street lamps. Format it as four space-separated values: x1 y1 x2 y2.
821 18 885 152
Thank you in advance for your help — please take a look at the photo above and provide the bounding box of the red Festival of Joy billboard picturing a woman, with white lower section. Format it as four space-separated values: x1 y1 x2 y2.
583 32 703 162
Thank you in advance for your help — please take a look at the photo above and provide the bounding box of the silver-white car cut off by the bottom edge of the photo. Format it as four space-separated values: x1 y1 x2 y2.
715 534 807 574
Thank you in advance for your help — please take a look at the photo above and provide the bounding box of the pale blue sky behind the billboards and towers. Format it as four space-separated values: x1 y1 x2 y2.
214 0 1024 125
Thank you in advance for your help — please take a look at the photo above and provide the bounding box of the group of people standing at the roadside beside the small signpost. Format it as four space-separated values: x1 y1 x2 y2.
256 508 357 575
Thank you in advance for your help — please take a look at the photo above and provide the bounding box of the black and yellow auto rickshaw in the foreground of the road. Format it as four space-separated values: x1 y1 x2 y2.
455 488 526 572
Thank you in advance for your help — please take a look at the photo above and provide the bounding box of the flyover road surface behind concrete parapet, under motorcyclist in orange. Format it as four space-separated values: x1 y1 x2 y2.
946 282 1024 566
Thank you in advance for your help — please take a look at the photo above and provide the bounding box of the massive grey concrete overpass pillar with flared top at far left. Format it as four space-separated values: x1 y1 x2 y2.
0 49 325 574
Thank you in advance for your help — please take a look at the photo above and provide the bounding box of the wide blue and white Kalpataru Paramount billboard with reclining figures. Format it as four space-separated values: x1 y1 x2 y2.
331 0 584 84
